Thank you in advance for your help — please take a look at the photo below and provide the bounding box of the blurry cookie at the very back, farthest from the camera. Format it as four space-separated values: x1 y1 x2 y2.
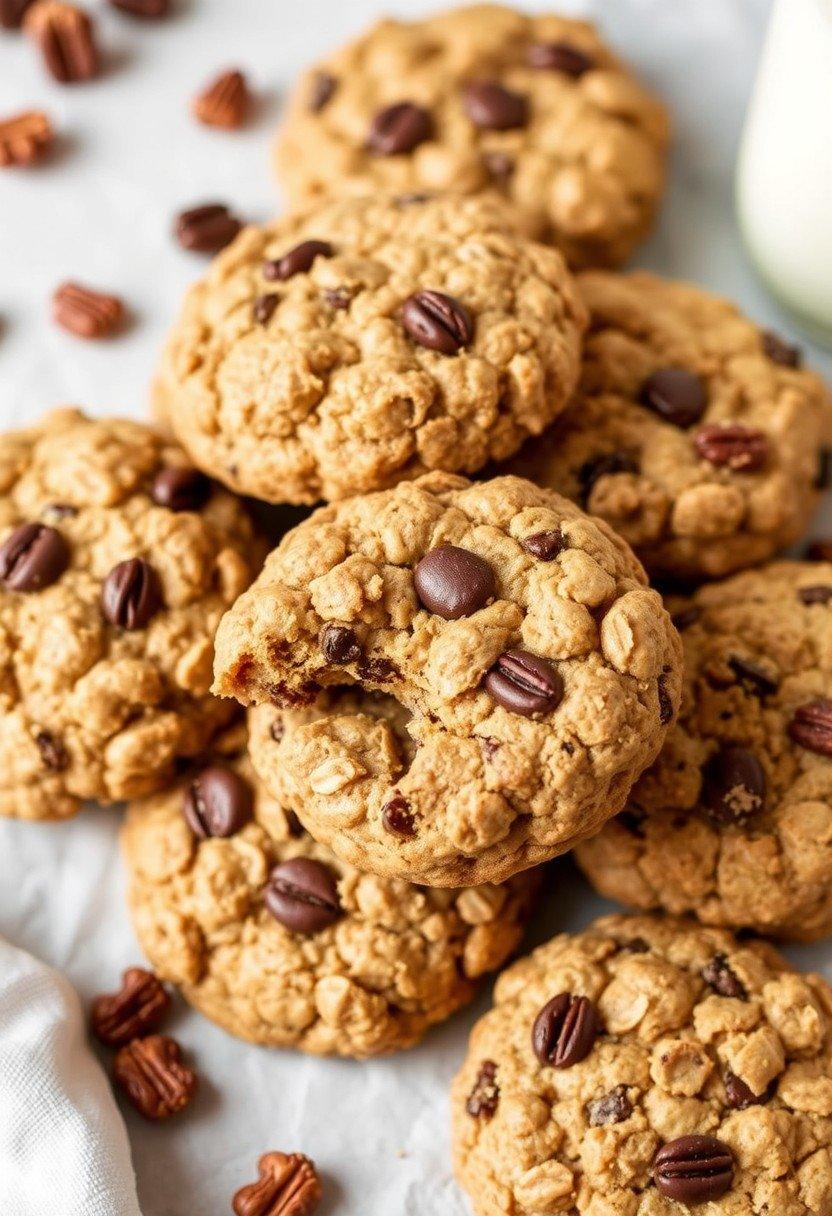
275 5 669 266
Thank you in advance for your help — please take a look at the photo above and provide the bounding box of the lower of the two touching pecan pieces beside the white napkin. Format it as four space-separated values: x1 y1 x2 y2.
113 1035 197 1120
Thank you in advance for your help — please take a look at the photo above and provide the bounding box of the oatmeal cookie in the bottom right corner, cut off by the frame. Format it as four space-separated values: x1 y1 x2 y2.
452 916 832 1216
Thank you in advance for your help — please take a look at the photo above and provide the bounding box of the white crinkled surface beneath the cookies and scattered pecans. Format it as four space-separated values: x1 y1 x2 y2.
0 0 832 1216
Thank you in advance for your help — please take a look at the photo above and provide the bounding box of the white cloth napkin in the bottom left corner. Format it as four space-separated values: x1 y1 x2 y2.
0 938 141 1216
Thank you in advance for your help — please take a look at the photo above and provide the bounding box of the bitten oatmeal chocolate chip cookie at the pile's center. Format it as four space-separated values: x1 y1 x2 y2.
215 473 681 886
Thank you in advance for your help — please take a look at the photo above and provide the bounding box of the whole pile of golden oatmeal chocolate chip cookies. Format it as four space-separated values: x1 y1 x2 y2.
0 6 832 1216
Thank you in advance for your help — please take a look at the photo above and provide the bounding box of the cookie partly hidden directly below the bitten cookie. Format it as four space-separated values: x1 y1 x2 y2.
122 724 538 1058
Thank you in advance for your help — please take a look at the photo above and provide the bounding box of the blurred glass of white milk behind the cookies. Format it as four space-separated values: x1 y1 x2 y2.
737 0 832 345
